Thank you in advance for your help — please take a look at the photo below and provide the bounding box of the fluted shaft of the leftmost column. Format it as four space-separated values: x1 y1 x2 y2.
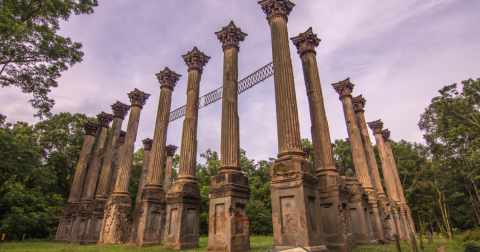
68 135 94 203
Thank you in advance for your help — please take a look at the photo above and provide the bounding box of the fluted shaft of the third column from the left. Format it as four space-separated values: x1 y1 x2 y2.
96 117 123 198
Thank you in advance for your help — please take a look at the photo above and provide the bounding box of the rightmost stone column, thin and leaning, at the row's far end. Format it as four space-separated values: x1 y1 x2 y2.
382 129 415 236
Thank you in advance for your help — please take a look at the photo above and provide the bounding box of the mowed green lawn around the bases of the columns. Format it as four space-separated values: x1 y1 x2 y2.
0 236 445 252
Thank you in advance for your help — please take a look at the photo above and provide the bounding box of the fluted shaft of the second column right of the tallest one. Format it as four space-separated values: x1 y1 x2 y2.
341 95 373 189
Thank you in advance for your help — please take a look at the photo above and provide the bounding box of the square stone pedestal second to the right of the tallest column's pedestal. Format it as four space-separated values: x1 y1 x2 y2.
345 177 379 245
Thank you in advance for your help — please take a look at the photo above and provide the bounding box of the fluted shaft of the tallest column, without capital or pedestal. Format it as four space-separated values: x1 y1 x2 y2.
269 14 303 157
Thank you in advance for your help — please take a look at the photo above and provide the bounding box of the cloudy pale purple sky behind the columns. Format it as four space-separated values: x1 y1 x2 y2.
0 0 480 162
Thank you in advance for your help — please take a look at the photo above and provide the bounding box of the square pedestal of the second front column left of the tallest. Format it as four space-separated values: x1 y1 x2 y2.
163 179 202 250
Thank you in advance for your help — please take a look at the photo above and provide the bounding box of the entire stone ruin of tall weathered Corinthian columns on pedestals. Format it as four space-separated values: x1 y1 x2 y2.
55 0 415 252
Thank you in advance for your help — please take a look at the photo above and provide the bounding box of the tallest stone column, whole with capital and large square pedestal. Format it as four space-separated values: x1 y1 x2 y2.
258 0 327 251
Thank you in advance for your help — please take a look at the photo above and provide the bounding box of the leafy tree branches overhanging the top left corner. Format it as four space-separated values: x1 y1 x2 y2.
0 0 98 118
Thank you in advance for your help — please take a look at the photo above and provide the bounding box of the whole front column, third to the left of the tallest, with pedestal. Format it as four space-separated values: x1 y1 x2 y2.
129 67 181 248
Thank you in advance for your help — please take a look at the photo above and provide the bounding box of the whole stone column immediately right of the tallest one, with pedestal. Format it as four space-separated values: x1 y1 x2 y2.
291 27 355 250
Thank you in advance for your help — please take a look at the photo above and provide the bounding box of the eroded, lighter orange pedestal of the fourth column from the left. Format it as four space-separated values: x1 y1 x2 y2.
97 193 132 245
